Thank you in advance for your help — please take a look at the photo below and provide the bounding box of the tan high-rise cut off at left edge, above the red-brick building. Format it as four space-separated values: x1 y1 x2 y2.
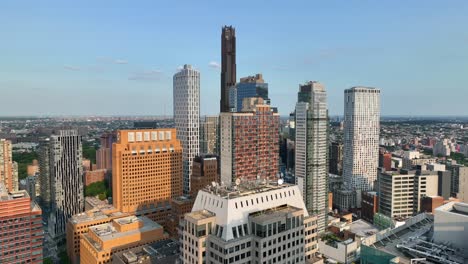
0 139 18 192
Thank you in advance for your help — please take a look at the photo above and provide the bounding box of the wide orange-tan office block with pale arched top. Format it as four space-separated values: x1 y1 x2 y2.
112 129 182 225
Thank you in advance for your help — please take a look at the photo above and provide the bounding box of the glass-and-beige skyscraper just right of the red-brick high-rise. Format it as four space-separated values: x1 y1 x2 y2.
295 82 328 232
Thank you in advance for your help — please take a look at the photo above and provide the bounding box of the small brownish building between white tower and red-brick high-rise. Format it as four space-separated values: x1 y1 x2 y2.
200 116 219 155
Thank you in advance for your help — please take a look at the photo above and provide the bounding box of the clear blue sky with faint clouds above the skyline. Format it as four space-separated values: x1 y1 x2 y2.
0 0 468 116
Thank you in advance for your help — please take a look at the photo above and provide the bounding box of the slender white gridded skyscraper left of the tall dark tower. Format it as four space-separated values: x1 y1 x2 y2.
173 65 200 194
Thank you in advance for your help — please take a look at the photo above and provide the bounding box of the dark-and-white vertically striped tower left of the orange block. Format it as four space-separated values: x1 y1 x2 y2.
40 130 84 238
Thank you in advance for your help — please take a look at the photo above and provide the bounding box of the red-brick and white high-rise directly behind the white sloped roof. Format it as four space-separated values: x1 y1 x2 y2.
220 98 280 185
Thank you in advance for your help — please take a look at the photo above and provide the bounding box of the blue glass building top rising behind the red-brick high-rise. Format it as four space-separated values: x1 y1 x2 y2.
229 74 270 112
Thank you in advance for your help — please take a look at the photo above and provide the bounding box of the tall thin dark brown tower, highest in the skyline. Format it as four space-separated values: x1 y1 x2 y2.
220 26 236 112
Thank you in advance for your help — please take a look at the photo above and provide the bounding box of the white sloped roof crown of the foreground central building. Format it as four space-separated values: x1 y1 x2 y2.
192 184 309 241
